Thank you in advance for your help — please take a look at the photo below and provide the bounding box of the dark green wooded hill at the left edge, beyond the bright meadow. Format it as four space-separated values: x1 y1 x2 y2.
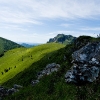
0 37 23 51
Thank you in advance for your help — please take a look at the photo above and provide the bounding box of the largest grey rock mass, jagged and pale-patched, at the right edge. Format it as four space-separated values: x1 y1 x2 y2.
65 42 100 84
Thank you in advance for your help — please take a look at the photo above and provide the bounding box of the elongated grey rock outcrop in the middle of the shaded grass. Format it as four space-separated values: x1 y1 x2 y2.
31 63 60 86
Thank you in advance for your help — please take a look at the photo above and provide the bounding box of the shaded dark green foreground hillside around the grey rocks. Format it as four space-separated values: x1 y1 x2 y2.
3 36 100 100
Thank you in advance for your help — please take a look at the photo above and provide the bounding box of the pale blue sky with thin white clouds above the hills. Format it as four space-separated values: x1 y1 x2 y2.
0 0 100 43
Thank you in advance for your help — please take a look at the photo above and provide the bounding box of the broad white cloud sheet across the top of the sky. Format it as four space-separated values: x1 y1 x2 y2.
0 0 100 24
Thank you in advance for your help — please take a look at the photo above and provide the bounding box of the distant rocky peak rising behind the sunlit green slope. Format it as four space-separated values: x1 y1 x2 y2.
48 34 76 44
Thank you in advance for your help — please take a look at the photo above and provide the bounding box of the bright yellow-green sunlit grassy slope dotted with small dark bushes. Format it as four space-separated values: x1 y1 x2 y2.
0 43 63 84
